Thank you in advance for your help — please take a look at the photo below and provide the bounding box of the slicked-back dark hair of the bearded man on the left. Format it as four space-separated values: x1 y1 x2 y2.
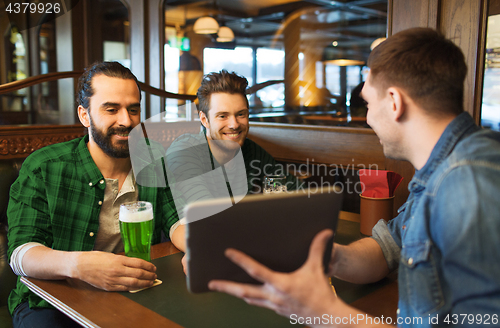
76 62 141 110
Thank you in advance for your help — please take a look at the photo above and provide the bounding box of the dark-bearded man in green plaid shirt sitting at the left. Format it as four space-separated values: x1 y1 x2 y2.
7 62 180 327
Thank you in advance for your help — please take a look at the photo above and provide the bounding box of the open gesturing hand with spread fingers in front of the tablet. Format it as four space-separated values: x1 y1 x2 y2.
209 230 341 317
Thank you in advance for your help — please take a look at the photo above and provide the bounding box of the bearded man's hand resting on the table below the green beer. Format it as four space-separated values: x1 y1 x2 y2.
72 251 156 291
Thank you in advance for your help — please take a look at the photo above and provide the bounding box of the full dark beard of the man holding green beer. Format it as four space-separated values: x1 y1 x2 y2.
89 115 132 158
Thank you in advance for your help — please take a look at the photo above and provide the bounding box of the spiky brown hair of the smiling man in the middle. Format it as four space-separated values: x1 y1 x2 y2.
197 69 248 118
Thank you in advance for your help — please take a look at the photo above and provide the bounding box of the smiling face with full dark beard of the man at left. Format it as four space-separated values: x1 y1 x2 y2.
78 74 141 158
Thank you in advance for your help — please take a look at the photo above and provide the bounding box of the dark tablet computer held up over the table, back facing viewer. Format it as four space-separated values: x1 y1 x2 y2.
185 187 342 293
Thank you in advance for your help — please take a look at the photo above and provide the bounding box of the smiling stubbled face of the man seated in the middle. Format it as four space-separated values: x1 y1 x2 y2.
200 93 249 147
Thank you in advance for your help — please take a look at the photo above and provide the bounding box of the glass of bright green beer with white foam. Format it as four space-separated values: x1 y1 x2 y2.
119 202 154 261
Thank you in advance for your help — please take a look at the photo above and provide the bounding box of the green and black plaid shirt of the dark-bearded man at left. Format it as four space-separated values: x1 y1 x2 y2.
7 136 178 314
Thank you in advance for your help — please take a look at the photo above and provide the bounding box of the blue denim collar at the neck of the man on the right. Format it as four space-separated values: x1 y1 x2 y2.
408 112 480 192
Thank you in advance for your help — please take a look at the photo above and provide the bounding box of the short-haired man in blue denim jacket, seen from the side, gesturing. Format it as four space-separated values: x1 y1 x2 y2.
210 28 500 327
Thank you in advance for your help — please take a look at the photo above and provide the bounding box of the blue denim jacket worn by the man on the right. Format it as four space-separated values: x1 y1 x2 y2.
373 113 500 327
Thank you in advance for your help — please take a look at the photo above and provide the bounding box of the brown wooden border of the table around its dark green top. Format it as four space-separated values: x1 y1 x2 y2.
21 212 398 328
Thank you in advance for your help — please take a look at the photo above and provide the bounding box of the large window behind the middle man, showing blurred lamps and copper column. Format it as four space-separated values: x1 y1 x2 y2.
164 0 387 125
